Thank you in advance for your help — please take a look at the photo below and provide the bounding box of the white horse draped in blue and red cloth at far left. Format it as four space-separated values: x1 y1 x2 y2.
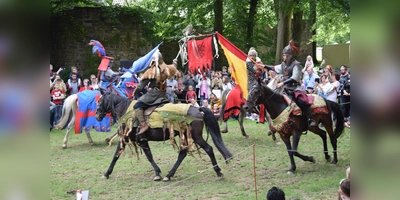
55 94 117 149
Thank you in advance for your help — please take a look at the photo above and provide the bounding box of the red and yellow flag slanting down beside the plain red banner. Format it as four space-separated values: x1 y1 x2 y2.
217 32 248 99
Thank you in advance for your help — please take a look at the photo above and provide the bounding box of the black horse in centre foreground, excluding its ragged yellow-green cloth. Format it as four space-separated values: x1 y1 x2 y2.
96 92 232 181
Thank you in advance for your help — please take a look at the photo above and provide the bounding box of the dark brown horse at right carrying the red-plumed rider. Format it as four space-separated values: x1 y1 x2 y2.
243 81 344 174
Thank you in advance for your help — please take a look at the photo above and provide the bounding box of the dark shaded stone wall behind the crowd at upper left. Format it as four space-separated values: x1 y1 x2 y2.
50 8 179 78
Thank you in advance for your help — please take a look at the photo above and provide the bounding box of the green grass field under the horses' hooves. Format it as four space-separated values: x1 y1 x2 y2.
50 120 350 200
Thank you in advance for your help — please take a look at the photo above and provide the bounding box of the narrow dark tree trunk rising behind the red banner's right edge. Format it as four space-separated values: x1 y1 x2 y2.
213 0 224 70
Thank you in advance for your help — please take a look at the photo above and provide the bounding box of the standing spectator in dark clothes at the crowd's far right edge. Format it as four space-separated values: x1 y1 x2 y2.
338 65 350 121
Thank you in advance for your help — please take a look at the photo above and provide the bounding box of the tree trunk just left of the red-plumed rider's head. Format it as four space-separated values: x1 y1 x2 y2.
275 0 293 64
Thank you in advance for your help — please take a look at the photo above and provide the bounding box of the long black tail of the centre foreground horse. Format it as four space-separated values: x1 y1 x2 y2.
200 107 233 163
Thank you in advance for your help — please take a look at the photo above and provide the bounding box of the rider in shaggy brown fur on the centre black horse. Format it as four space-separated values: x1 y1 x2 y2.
133 52 177 135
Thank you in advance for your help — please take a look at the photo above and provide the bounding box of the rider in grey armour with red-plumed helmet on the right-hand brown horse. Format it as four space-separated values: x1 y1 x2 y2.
264 40 317 127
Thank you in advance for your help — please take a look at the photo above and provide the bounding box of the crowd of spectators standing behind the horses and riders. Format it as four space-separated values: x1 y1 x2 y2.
50 52 350 128
